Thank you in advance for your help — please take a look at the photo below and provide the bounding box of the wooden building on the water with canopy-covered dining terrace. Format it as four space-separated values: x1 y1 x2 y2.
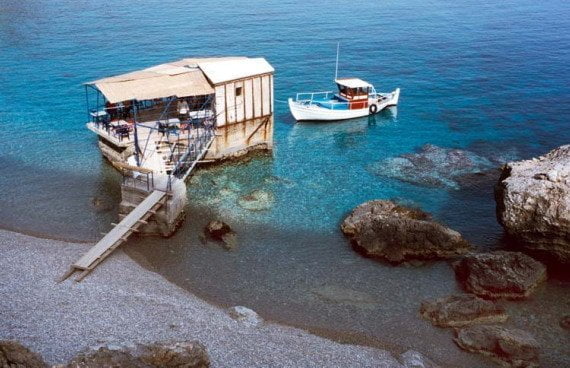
82 57 274 178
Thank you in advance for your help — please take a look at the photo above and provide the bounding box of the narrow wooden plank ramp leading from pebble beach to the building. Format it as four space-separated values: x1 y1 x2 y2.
61 190 167 282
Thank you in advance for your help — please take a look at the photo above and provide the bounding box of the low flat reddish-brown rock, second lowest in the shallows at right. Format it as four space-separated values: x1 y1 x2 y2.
420 294 508 327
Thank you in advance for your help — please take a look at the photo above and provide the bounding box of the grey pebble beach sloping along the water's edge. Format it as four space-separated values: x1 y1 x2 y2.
0 230 434 367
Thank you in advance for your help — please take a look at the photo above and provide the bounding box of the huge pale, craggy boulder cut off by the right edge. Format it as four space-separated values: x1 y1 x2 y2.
495 145 570 264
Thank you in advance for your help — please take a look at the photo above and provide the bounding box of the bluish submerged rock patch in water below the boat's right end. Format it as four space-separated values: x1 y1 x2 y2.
370 144 494 189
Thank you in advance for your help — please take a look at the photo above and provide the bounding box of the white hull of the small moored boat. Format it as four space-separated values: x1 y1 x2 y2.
288 88 400 121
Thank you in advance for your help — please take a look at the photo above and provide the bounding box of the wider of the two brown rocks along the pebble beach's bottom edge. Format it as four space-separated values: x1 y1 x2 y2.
66 341 210 368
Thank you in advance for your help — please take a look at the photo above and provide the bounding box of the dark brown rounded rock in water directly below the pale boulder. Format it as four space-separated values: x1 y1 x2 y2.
453 251 546 299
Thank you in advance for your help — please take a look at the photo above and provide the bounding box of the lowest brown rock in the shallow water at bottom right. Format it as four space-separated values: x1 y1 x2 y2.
454 325 540 368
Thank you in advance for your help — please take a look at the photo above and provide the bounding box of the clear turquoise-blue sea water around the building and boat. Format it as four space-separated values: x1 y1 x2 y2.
0 0 570 367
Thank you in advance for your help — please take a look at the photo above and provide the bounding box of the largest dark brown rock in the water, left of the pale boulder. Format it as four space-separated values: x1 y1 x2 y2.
341 200 469 263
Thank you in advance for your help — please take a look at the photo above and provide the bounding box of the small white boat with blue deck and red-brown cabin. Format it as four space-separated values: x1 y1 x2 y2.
288 78 400 121
